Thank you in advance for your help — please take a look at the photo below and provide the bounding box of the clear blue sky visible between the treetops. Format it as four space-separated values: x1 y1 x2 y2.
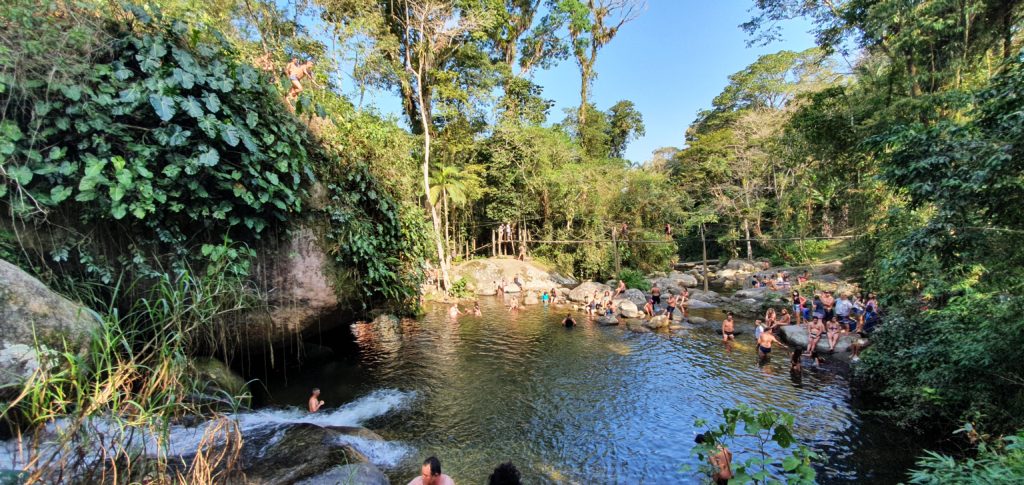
352 0 814 163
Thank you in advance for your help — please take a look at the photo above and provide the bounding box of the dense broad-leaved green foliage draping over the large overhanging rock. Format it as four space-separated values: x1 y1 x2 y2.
0 2 422 300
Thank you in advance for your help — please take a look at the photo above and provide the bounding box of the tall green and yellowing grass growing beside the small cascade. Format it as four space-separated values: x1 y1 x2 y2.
0 272 248 483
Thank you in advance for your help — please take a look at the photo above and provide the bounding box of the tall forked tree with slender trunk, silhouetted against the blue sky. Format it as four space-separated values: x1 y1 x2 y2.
558 0 647 125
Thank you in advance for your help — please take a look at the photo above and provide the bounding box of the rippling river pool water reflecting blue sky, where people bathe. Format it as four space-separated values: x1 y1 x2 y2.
256 299 919 483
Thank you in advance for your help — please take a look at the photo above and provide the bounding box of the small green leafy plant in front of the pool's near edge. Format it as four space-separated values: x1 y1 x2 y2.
693 404 817 484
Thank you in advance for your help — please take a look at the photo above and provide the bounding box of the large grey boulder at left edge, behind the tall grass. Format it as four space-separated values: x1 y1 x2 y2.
0 260 101 398
